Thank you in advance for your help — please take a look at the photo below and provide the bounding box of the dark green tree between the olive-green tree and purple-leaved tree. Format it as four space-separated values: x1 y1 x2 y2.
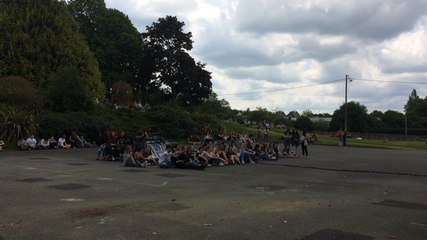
69 0 146 94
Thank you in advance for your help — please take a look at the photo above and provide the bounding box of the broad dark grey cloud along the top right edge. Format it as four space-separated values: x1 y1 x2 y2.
236 0 427 40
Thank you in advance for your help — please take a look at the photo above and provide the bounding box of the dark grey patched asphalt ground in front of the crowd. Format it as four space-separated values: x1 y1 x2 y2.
0 145 427 240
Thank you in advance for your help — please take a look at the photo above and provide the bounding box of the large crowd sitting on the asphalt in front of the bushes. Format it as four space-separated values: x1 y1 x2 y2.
118 134 306 170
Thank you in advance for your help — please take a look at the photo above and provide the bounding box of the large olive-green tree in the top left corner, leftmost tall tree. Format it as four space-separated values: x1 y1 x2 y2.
0 0 105 98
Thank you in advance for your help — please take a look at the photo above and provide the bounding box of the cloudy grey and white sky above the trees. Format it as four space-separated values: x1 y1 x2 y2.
106 0 427 113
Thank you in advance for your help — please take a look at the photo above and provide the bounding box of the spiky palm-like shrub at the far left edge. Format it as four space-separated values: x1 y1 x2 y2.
0 104 37 142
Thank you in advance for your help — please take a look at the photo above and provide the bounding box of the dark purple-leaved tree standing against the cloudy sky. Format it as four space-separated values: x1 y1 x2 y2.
142 16 212 105
